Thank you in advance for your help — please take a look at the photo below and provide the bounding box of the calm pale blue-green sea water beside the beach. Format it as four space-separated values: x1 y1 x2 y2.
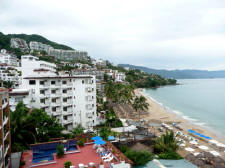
144 78 225 135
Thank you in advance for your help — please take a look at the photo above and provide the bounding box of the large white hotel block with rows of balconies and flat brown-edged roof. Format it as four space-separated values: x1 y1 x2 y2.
23 75 98 130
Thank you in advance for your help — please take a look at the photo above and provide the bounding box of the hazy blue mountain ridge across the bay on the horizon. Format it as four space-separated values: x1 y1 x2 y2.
118 64 225 79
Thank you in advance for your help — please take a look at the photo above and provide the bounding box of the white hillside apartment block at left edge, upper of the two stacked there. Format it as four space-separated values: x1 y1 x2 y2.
0 49 19 66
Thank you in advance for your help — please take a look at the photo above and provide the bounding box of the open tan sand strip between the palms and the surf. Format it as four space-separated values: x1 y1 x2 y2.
135 89 225 143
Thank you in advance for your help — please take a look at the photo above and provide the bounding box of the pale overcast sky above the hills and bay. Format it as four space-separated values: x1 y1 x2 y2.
0 0 225 70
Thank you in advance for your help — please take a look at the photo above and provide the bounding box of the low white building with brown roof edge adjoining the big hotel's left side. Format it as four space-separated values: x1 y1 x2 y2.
9 89 31 111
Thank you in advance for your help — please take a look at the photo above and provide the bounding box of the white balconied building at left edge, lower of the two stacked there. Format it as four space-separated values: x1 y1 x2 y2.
0 64 22 88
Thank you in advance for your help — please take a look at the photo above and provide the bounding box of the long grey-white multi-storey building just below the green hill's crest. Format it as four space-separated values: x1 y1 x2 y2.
48 49 88 61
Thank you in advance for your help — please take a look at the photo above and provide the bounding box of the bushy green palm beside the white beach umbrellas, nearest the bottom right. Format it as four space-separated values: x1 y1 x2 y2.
154 131 179 153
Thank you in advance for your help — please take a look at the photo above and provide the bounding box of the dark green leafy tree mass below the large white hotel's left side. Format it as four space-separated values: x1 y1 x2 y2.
10 102 64 151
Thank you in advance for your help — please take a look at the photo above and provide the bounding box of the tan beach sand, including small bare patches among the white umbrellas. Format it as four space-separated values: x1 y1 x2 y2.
135 89 225 157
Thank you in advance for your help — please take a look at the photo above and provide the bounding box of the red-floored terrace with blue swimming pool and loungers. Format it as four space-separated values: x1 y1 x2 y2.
21 140 132 168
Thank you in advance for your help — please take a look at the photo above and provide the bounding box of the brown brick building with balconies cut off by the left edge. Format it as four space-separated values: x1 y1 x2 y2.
0 88 11 168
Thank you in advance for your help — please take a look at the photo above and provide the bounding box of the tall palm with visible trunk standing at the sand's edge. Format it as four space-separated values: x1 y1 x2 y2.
132 96 149 122
